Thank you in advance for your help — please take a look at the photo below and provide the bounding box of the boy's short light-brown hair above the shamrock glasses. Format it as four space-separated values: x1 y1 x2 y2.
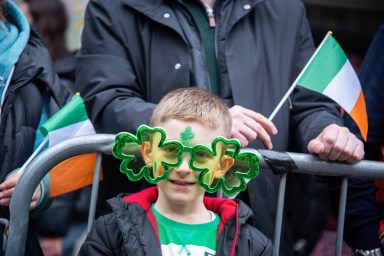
150 87 232 137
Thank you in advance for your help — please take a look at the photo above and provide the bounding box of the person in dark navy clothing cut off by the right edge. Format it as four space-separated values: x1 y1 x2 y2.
331 25 384 255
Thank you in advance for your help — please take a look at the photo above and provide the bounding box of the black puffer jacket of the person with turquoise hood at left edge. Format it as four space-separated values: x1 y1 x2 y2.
0 30 70 255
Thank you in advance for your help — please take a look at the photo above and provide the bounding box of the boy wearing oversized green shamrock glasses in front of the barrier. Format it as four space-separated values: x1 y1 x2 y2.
79 88 273 256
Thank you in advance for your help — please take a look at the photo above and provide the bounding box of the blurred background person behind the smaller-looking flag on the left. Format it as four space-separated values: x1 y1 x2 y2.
20 0 91 256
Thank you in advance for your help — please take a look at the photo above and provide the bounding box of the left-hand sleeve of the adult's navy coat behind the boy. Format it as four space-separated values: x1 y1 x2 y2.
76 0 155 133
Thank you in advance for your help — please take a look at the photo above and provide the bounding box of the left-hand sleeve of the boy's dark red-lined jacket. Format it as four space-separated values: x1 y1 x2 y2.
78 214 124 256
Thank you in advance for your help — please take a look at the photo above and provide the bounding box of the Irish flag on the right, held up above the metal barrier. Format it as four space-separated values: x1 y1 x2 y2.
297 32 368 140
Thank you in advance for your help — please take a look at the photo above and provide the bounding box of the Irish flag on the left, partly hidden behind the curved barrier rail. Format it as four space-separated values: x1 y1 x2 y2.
40 94 101 197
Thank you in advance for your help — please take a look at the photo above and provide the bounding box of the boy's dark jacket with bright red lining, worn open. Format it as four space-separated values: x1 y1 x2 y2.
79 188 273 256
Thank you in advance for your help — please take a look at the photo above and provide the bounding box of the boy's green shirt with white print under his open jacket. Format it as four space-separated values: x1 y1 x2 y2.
151 204 220 256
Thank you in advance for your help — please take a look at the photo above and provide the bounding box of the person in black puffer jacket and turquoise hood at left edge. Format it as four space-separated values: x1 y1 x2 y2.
0 0 69 255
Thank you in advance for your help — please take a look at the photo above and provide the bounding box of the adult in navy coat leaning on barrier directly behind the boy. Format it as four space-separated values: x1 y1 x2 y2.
76 0 364 255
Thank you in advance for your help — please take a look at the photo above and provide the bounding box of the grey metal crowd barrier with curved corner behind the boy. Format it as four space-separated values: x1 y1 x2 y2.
5 134 384 256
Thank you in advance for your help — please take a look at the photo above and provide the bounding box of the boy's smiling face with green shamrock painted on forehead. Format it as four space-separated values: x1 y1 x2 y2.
144 119 226 204
